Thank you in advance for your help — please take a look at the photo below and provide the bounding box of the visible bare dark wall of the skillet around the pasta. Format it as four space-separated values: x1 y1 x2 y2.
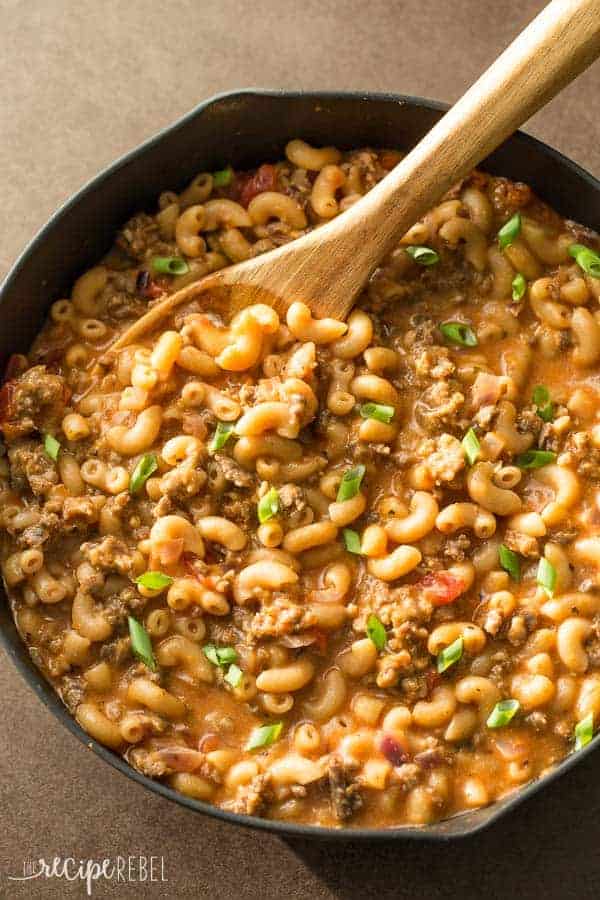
0 91 600 840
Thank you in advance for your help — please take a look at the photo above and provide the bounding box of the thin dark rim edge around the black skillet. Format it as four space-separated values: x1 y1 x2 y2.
0 87 600 843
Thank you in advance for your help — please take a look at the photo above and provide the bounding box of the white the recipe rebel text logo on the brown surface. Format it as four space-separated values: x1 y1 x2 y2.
7 856 169 897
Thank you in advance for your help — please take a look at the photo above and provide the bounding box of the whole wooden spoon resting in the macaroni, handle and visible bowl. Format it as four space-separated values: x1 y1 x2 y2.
113 0 600 349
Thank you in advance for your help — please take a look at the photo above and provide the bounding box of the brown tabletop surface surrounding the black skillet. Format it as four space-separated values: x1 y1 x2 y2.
0 0 600 900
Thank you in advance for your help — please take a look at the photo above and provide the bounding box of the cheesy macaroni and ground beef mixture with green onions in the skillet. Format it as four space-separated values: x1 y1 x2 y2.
0 140 600 826
